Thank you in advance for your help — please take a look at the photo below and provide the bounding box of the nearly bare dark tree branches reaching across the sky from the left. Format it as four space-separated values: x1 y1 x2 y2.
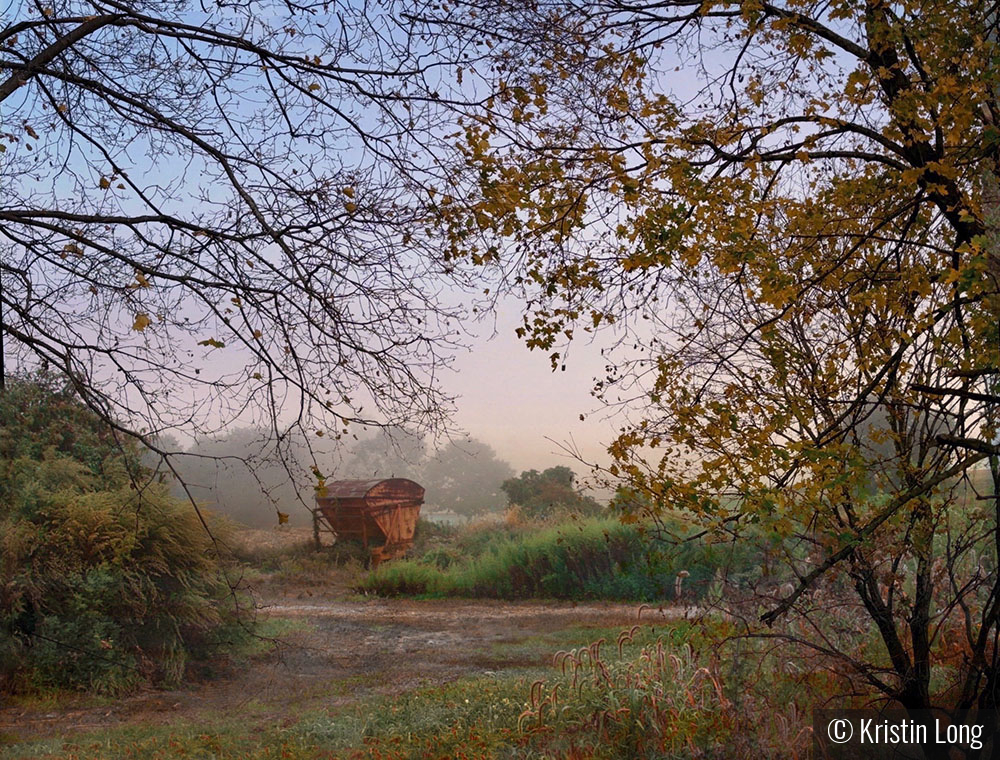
0 0 480 504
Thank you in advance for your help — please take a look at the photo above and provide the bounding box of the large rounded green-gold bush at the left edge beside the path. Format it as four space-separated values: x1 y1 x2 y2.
0 379 240 693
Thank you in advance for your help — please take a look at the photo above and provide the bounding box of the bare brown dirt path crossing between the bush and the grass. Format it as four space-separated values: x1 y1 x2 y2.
0 599 679 740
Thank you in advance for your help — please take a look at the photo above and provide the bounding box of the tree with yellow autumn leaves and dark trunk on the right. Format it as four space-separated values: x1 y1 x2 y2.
414 0 1000 736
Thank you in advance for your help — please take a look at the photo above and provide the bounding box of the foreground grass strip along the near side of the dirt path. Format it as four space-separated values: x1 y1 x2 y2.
0 622 805 760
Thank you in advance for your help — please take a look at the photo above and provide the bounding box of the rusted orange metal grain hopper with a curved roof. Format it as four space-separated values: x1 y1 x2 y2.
313 478 424 565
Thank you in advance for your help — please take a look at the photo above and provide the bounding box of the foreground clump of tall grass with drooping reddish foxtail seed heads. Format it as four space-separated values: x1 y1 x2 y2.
518 621 816 760
